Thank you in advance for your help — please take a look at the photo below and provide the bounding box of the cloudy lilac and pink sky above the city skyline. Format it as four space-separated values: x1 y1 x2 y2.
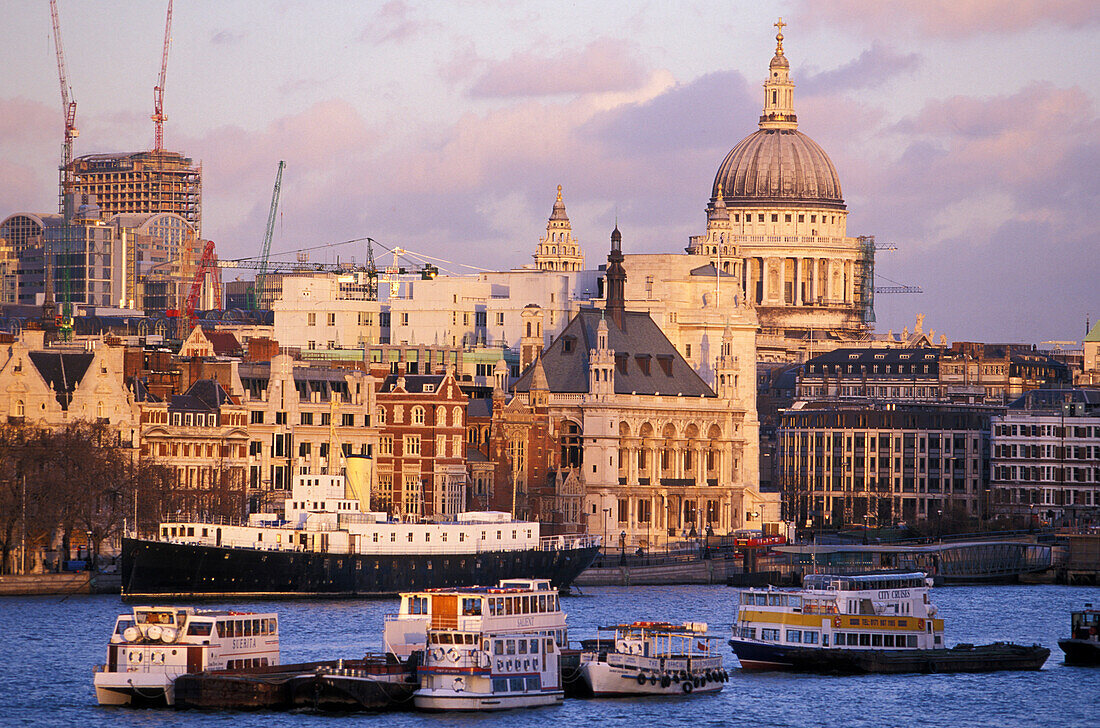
0 0 1100 343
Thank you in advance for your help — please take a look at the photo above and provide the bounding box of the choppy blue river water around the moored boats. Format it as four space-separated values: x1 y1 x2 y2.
0 586 1100 728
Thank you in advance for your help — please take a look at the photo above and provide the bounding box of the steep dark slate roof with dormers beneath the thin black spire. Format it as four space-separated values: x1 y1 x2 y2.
516 308 715 397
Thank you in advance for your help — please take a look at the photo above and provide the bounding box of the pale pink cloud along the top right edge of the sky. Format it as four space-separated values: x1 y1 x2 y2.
800 0 1100 37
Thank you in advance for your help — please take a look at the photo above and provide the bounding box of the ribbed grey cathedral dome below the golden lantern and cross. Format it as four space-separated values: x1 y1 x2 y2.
711 129 845 210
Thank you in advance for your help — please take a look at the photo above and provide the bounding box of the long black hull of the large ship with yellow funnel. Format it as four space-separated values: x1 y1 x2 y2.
122 539 598 599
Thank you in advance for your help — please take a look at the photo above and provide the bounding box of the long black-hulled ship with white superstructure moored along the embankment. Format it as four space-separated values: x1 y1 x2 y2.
121 475 600 600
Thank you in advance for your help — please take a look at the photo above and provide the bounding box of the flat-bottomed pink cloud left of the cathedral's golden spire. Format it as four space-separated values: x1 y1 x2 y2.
470 37 646 97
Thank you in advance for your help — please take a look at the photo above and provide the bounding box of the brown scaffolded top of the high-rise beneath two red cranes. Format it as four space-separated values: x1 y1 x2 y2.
65 150 202 235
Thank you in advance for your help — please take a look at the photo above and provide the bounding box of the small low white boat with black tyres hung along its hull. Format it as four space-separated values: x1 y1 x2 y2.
581 621 729 697
